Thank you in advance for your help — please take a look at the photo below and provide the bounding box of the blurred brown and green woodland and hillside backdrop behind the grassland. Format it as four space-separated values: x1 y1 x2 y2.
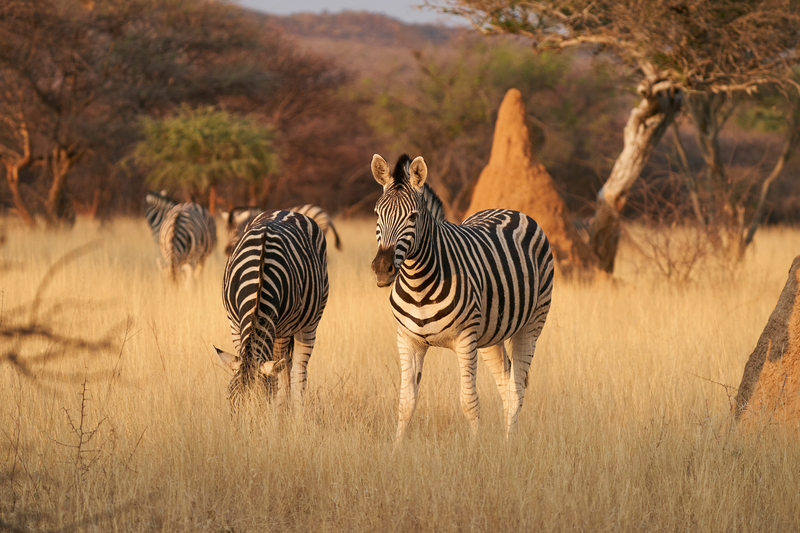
0 0 800 232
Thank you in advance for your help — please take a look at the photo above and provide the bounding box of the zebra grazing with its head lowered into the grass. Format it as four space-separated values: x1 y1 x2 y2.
212 211 328 411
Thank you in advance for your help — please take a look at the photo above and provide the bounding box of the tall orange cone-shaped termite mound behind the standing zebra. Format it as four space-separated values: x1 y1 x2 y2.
467 89 596 274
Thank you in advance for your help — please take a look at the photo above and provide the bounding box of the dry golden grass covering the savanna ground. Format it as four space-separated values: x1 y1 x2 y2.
0 220 800 532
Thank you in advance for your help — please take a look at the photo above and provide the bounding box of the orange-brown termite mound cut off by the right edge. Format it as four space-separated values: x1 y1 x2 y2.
734 255 800 429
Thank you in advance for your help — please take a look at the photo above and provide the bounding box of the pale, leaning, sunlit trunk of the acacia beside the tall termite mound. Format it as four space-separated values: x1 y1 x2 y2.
589 76 683 272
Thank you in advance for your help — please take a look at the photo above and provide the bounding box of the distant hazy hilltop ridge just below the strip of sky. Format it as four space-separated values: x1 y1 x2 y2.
269 11 465 46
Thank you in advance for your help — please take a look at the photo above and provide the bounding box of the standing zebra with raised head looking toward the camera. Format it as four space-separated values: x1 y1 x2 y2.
372 154 553 445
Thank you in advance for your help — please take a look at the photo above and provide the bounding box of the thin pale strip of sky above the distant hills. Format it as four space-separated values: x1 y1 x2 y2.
234 0 456 26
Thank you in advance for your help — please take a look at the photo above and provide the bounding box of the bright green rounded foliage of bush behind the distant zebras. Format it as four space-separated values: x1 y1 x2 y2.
133 105 277 191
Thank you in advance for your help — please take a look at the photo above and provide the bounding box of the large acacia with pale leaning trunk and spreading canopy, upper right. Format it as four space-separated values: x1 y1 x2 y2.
434 0 800 272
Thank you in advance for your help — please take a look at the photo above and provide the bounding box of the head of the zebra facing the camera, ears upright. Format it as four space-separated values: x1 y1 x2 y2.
372 154 428 287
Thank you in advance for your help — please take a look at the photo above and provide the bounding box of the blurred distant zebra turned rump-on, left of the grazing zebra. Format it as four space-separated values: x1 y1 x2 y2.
158 202 217 281
